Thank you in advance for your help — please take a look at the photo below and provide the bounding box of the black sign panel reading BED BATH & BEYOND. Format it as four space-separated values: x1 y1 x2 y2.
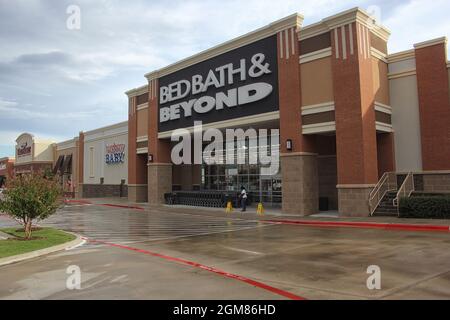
159 36 279 132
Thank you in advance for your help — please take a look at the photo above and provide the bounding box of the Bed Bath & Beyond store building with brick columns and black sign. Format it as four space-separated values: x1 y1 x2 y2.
126 9 450 216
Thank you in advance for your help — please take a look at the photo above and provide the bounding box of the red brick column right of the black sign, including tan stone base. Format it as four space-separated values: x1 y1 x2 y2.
277 28 319 216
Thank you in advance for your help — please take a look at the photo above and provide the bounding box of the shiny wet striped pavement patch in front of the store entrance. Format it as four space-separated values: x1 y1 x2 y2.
42 205 266 243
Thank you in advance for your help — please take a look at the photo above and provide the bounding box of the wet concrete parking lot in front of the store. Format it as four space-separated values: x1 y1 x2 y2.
0 204 450 299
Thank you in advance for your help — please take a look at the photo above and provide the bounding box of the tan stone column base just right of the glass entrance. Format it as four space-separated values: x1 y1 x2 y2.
281 155 319 216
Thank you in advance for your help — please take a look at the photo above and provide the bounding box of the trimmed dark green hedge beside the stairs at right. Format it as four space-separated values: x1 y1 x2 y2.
399 196 450 219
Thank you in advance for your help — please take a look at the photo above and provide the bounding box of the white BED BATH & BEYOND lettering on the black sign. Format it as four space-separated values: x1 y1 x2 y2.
159 53 273 122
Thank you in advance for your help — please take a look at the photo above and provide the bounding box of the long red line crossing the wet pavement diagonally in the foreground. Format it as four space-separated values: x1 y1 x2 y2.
83 238 306 300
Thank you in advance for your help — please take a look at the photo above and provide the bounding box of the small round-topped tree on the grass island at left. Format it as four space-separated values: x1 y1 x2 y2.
0 173 63 240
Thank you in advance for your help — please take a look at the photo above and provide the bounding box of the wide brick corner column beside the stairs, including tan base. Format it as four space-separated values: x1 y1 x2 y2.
331 22 378 216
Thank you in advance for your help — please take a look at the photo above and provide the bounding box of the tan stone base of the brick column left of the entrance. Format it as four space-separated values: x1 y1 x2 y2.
148 164 172 205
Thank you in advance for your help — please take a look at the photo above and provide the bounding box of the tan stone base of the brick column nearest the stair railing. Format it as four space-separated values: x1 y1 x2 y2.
338 187 373 217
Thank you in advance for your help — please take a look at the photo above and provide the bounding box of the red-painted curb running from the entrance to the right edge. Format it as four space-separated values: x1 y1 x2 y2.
262 220 450 233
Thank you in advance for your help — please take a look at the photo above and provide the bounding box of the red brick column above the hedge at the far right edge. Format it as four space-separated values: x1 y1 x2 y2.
415 38 450 170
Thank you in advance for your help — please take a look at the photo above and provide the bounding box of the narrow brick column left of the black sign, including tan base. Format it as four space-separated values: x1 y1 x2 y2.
148 79 172 205
